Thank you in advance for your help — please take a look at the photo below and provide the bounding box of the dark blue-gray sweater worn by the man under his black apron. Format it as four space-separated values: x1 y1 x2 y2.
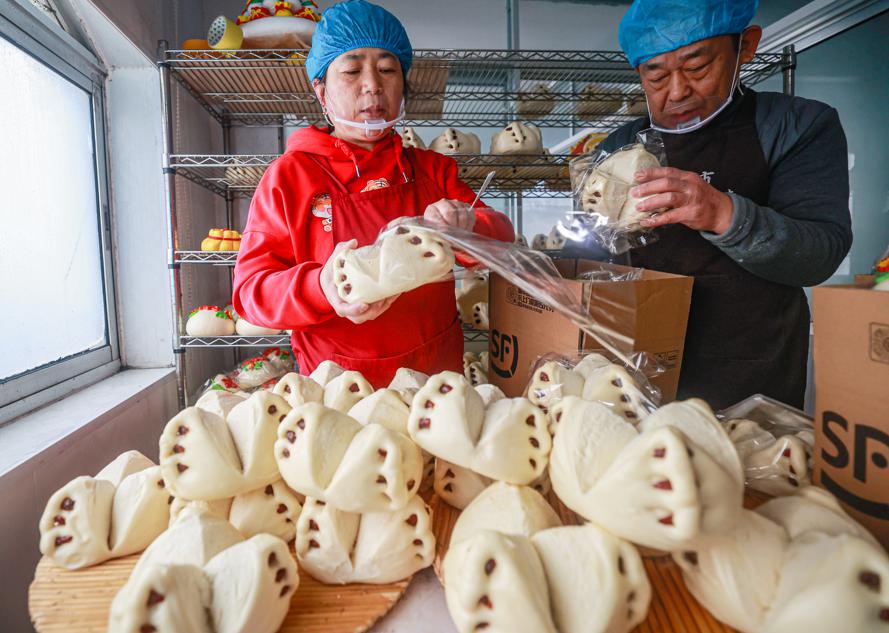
600 88 852 286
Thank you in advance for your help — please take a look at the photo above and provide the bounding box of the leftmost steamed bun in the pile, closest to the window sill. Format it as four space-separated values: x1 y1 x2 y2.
39 451 170 569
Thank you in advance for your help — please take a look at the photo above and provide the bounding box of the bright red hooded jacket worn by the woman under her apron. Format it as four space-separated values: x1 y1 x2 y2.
233 127 514 378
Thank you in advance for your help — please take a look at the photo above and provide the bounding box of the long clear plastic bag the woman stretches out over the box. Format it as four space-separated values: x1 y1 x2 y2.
377 217 658 372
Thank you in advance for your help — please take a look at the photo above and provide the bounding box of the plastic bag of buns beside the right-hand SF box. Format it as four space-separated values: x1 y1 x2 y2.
718 395 815 496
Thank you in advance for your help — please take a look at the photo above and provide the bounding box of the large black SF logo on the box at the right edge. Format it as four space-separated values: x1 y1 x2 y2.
821 411 889 521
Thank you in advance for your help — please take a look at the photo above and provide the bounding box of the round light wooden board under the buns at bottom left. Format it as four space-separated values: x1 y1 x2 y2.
28 554 410 633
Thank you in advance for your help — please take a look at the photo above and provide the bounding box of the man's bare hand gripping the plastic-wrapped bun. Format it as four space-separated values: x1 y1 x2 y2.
630 167 733 235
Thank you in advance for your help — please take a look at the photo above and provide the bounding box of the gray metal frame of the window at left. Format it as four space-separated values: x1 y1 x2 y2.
0 0 120 424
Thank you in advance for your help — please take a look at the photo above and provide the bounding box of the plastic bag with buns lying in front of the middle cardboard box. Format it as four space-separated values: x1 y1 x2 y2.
525 352 661 424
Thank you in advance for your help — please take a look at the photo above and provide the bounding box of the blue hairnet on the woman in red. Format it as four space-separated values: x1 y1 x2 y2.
306 0 414 81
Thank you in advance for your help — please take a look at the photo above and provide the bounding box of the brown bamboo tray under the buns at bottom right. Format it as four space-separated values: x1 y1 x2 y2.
429 491 768 633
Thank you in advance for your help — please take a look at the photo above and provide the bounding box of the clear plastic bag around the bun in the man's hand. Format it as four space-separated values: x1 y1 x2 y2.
559 130 666 254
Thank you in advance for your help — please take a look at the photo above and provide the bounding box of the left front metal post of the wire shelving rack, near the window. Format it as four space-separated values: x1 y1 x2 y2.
157 40 187 409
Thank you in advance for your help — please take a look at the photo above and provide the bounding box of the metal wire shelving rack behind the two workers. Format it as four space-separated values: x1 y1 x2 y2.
158 42 796 404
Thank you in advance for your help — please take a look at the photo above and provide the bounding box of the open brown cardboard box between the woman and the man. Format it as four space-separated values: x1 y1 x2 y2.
488 259 693 402
